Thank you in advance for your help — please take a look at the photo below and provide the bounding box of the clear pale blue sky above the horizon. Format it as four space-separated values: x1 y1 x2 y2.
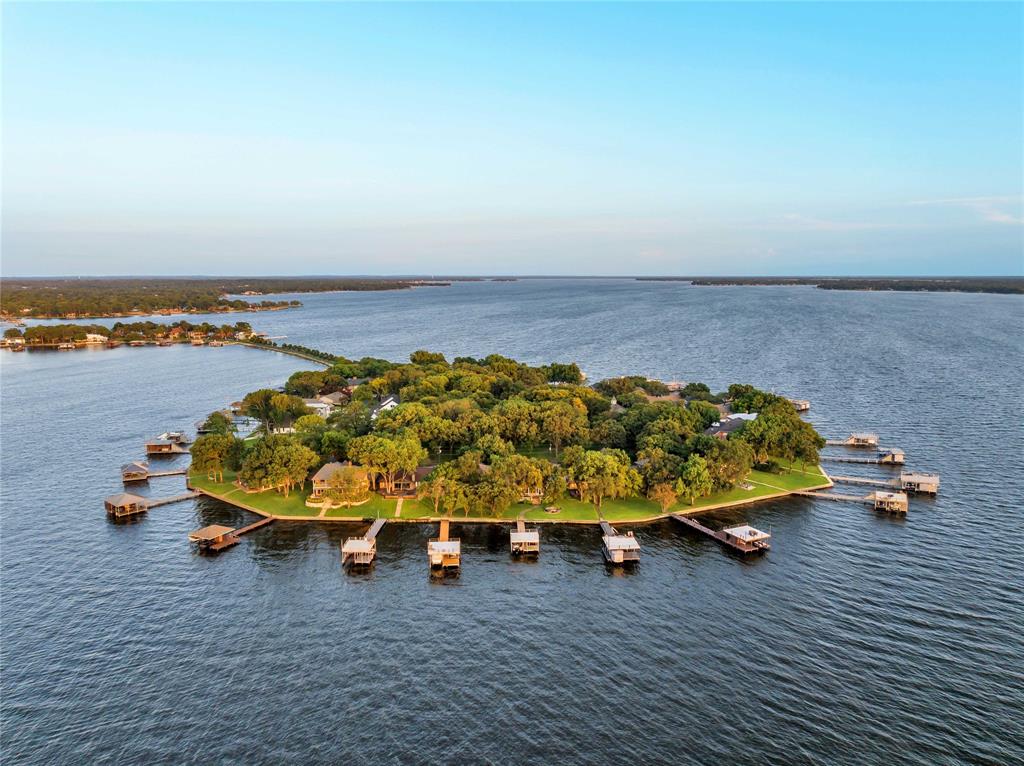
0 3 1024 275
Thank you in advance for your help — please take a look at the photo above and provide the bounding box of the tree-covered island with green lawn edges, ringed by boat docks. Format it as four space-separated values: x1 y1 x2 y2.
193 351 827 520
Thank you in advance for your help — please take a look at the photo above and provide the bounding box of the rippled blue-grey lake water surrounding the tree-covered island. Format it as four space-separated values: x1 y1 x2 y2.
0 280 1024 764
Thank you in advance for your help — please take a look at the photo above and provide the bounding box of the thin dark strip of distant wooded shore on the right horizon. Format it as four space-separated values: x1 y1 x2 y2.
637 276 1024 293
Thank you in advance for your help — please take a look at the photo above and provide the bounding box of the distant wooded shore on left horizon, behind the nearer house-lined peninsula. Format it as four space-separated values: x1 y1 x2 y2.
0 278 447 318
